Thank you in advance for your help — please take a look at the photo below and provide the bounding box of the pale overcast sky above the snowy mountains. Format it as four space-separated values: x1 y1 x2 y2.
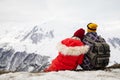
0 0 120 23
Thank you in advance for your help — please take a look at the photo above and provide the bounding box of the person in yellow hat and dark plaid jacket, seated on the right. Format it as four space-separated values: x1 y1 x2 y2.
80 23 109 70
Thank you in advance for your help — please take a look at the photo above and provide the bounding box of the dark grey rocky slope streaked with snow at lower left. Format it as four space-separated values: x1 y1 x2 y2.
0 48 49 72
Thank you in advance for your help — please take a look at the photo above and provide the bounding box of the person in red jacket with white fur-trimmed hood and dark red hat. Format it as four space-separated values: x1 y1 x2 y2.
44 28 89 72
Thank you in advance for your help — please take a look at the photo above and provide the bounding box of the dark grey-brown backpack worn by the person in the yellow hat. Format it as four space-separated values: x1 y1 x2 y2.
81 36 110 70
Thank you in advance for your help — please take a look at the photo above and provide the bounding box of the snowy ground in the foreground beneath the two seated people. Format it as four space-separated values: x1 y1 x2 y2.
0 69 120 80
